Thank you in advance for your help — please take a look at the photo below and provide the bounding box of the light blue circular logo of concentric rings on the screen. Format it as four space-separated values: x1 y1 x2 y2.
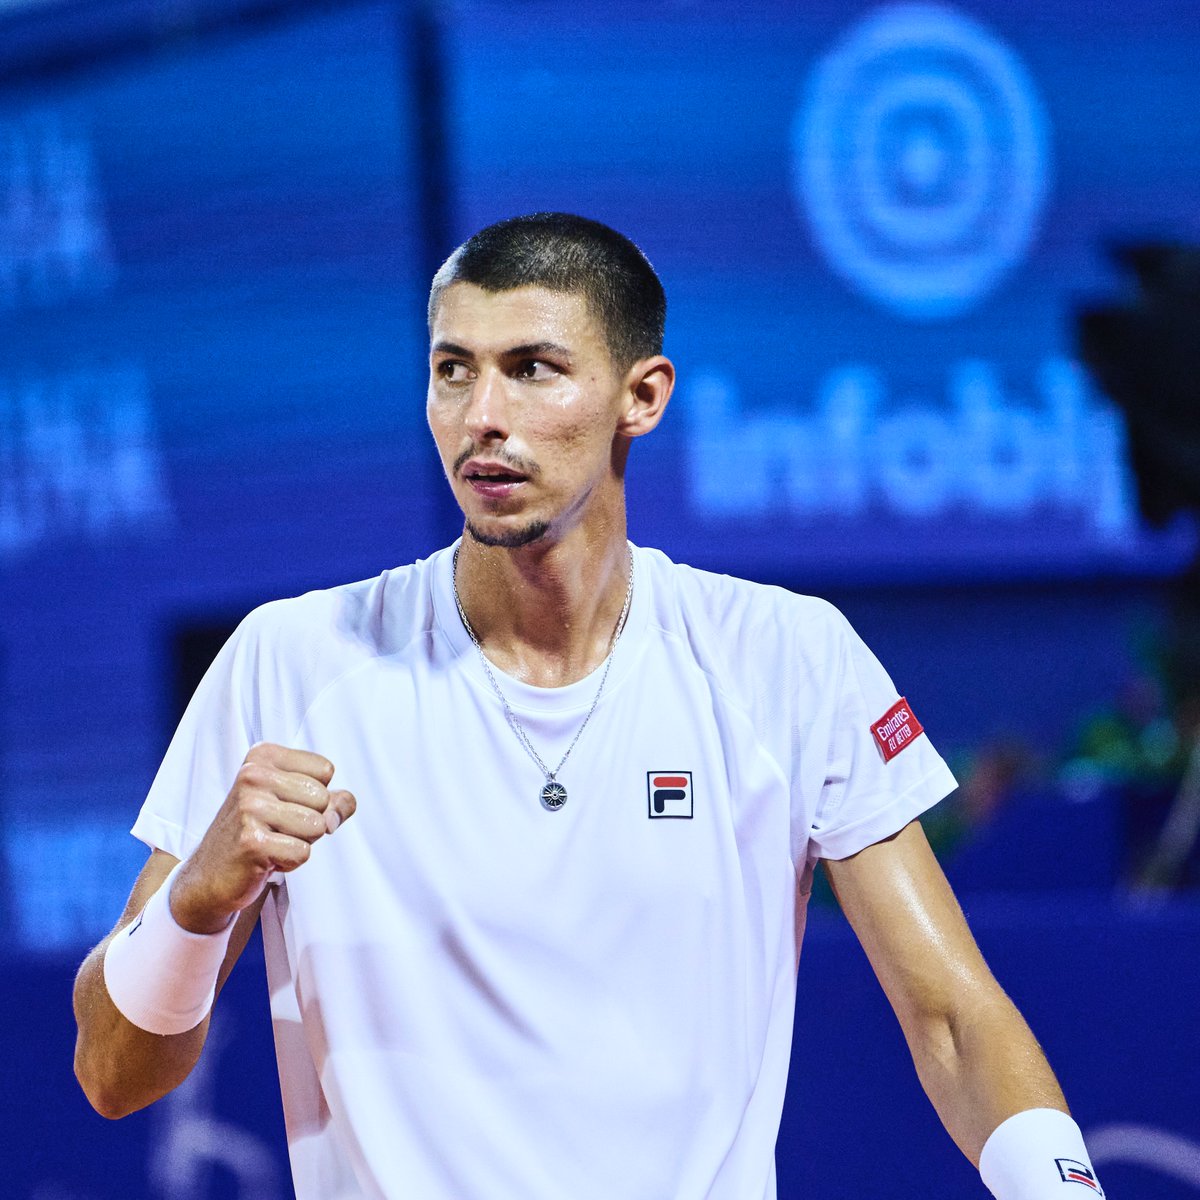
792 4 1049 320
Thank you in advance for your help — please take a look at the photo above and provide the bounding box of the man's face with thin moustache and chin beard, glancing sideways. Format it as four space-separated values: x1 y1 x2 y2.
426 283 628 546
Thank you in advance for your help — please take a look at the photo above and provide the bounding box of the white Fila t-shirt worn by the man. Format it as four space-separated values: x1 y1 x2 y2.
133 547 954 1200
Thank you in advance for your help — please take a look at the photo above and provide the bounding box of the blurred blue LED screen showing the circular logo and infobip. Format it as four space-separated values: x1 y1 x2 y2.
446 0 1200 583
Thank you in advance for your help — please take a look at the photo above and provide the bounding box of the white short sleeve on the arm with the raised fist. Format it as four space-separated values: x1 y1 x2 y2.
133 613 263 859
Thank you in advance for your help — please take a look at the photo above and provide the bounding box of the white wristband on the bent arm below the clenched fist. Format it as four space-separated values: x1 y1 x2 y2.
104 863 235 1034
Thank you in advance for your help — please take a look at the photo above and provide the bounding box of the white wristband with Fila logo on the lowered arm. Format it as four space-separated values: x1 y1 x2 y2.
979 1109 1104 1200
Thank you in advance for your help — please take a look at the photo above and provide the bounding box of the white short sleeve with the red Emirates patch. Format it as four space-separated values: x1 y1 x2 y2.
808 613 958 858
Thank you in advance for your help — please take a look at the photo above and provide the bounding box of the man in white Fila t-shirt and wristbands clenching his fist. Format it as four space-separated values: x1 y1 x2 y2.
76 214 1099 1200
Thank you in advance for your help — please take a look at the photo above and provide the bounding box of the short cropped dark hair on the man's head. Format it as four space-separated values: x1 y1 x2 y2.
428 212 667 370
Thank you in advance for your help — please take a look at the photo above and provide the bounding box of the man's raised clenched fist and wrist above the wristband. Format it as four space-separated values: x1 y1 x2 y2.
170 742 356 934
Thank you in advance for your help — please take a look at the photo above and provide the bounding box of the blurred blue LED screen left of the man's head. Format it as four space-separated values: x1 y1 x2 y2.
0 5 440 943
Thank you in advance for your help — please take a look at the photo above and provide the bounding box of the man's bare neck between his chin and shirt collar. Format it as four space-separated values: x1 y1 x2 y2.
456 522 631 688
